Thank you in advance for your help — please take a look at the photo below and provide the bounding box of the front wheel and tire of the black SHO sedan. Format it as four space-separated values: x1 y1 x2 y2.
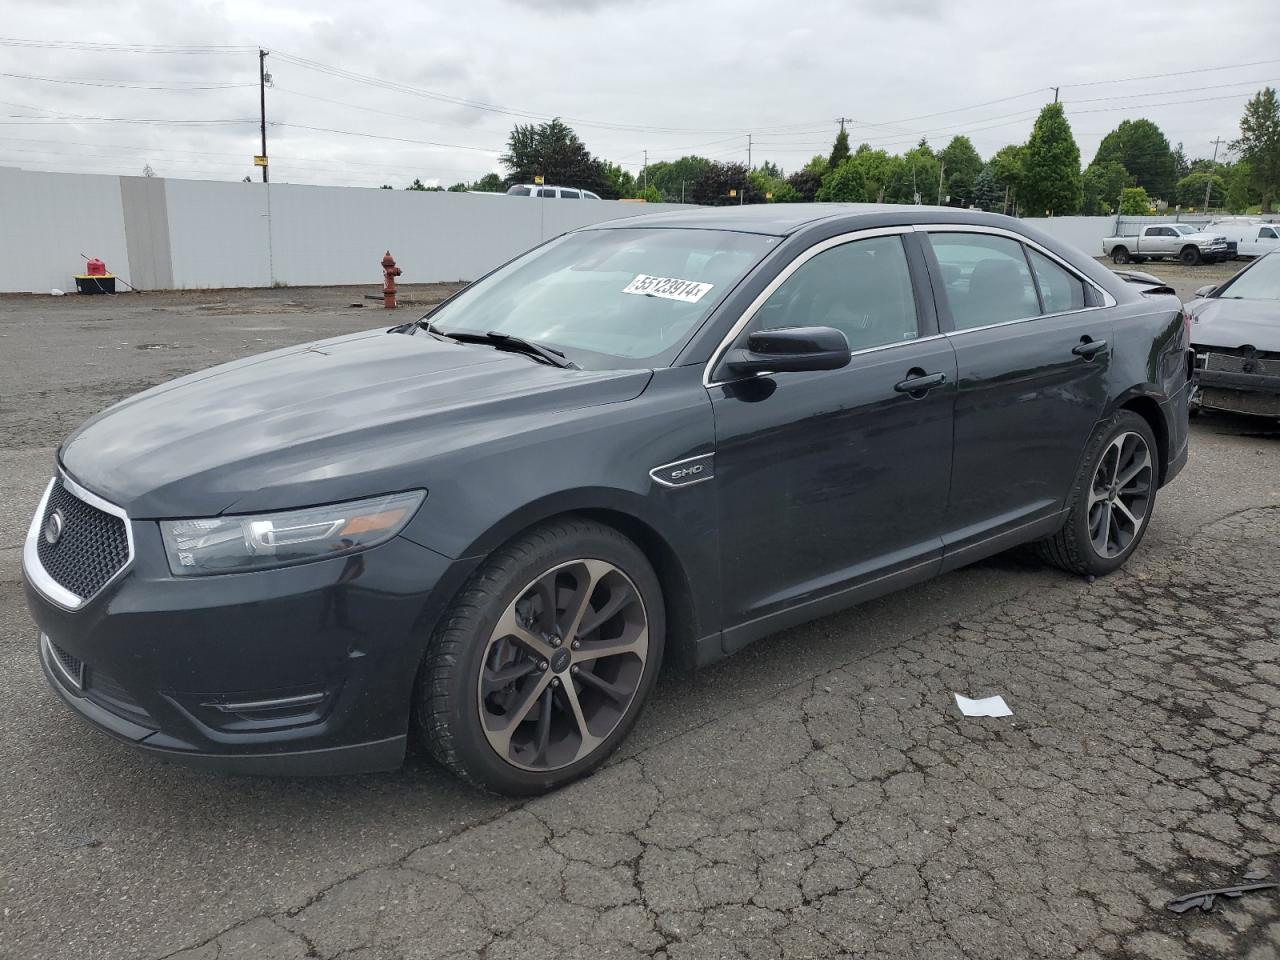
413 517 666 796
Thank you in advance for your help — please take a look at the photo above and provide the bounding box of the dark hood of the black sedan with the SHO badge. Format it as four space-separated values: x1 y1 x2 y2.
59 330 652 518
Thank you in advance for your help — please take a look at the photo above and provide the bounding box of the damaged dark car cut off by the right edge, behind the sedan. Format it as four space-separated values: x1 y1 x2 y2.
1188 253 1280 417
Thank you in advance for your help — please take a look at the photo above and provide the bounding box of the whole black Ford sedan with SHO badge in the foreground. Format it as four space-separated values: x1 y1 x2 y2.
23 205 1189 794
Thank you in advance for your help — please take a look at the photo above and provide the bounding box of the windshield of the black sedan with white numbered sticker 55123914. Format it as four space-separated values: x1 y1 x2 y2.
429 228 781 369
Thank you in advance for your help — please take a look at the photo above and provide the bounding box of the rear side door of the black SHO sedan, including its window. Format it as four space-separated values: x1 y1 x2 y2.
929 232 1111 554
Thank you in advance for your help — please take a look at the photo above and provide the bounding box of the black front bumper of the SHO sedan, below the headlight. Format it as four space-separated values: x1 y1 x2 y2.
23 496 468 774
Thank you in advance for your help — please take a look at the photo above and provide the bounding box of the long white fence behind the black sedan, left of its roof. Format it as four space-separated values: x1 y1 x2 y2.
0 168 682 293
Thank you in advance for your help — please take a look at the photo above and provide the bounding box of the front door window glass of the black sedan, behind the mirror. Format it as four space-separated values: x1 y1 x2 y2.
751 237 919 349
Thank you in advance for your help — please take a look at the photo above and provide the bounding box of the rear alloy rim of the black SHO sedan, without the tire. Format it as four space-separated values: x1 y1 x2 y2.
1089 433 1155 559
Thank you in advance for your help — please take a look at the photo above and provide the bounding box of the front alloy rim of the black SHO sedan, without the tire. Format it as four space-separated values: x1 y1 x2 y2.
477 559 649 772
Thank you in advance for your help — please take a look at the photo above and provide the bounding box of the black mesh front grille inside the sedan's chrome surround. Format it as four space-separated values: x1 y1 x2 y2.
36 477 129 600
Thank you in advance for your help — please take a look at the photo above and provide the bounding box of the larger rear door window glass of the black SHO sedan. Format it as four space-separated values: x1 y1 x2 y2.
929 233 1041 330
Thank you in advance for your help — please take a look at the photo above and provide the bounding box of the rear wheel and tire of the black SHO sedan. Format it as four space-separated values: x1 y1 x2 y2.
1036 410 1160 576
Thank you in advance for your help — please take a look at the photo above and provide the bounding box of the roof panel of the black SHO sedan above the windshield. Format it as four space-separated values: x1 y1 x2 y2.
582 204 1034 237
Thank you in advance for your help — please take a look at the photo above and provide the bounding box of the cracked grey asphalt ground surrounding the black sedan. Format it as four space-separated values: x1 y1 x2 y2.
0 291 1280 960
